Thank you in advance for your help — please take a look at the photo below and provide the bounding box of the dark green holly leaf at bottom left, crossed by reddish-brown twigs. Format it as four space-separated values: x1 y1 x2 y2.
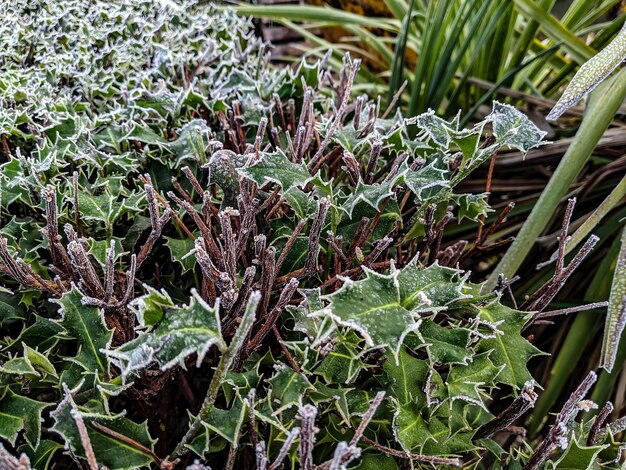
50 397 155 470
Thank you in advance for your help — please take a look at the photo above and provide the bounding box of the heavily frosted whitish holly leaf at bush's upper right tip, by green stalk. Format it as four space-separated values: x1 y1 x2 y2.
486 101 548 153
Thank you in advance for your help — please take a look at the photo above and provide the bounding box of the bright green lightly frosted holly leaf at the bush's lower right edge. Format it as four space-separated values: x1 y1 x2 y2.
475 299 541 389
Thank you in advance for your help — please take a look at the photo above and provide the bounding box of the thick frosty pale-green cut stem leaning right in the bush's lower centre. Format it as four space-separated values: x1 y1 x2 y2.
167 292 261 462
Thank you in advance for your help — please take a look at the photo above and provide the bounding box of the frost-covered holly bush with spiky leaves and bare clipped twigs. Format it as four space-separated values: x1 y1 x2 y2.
0 0 619 469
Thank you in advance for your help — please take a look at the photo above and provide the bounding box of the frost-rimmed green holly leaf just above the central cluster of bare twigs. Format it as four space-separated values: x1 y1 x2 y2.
237 149 311 191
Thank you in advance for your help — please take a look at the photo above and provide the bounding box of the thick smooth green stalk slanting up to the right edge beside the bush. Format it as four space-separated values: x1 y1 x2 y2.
483 69 626 291
